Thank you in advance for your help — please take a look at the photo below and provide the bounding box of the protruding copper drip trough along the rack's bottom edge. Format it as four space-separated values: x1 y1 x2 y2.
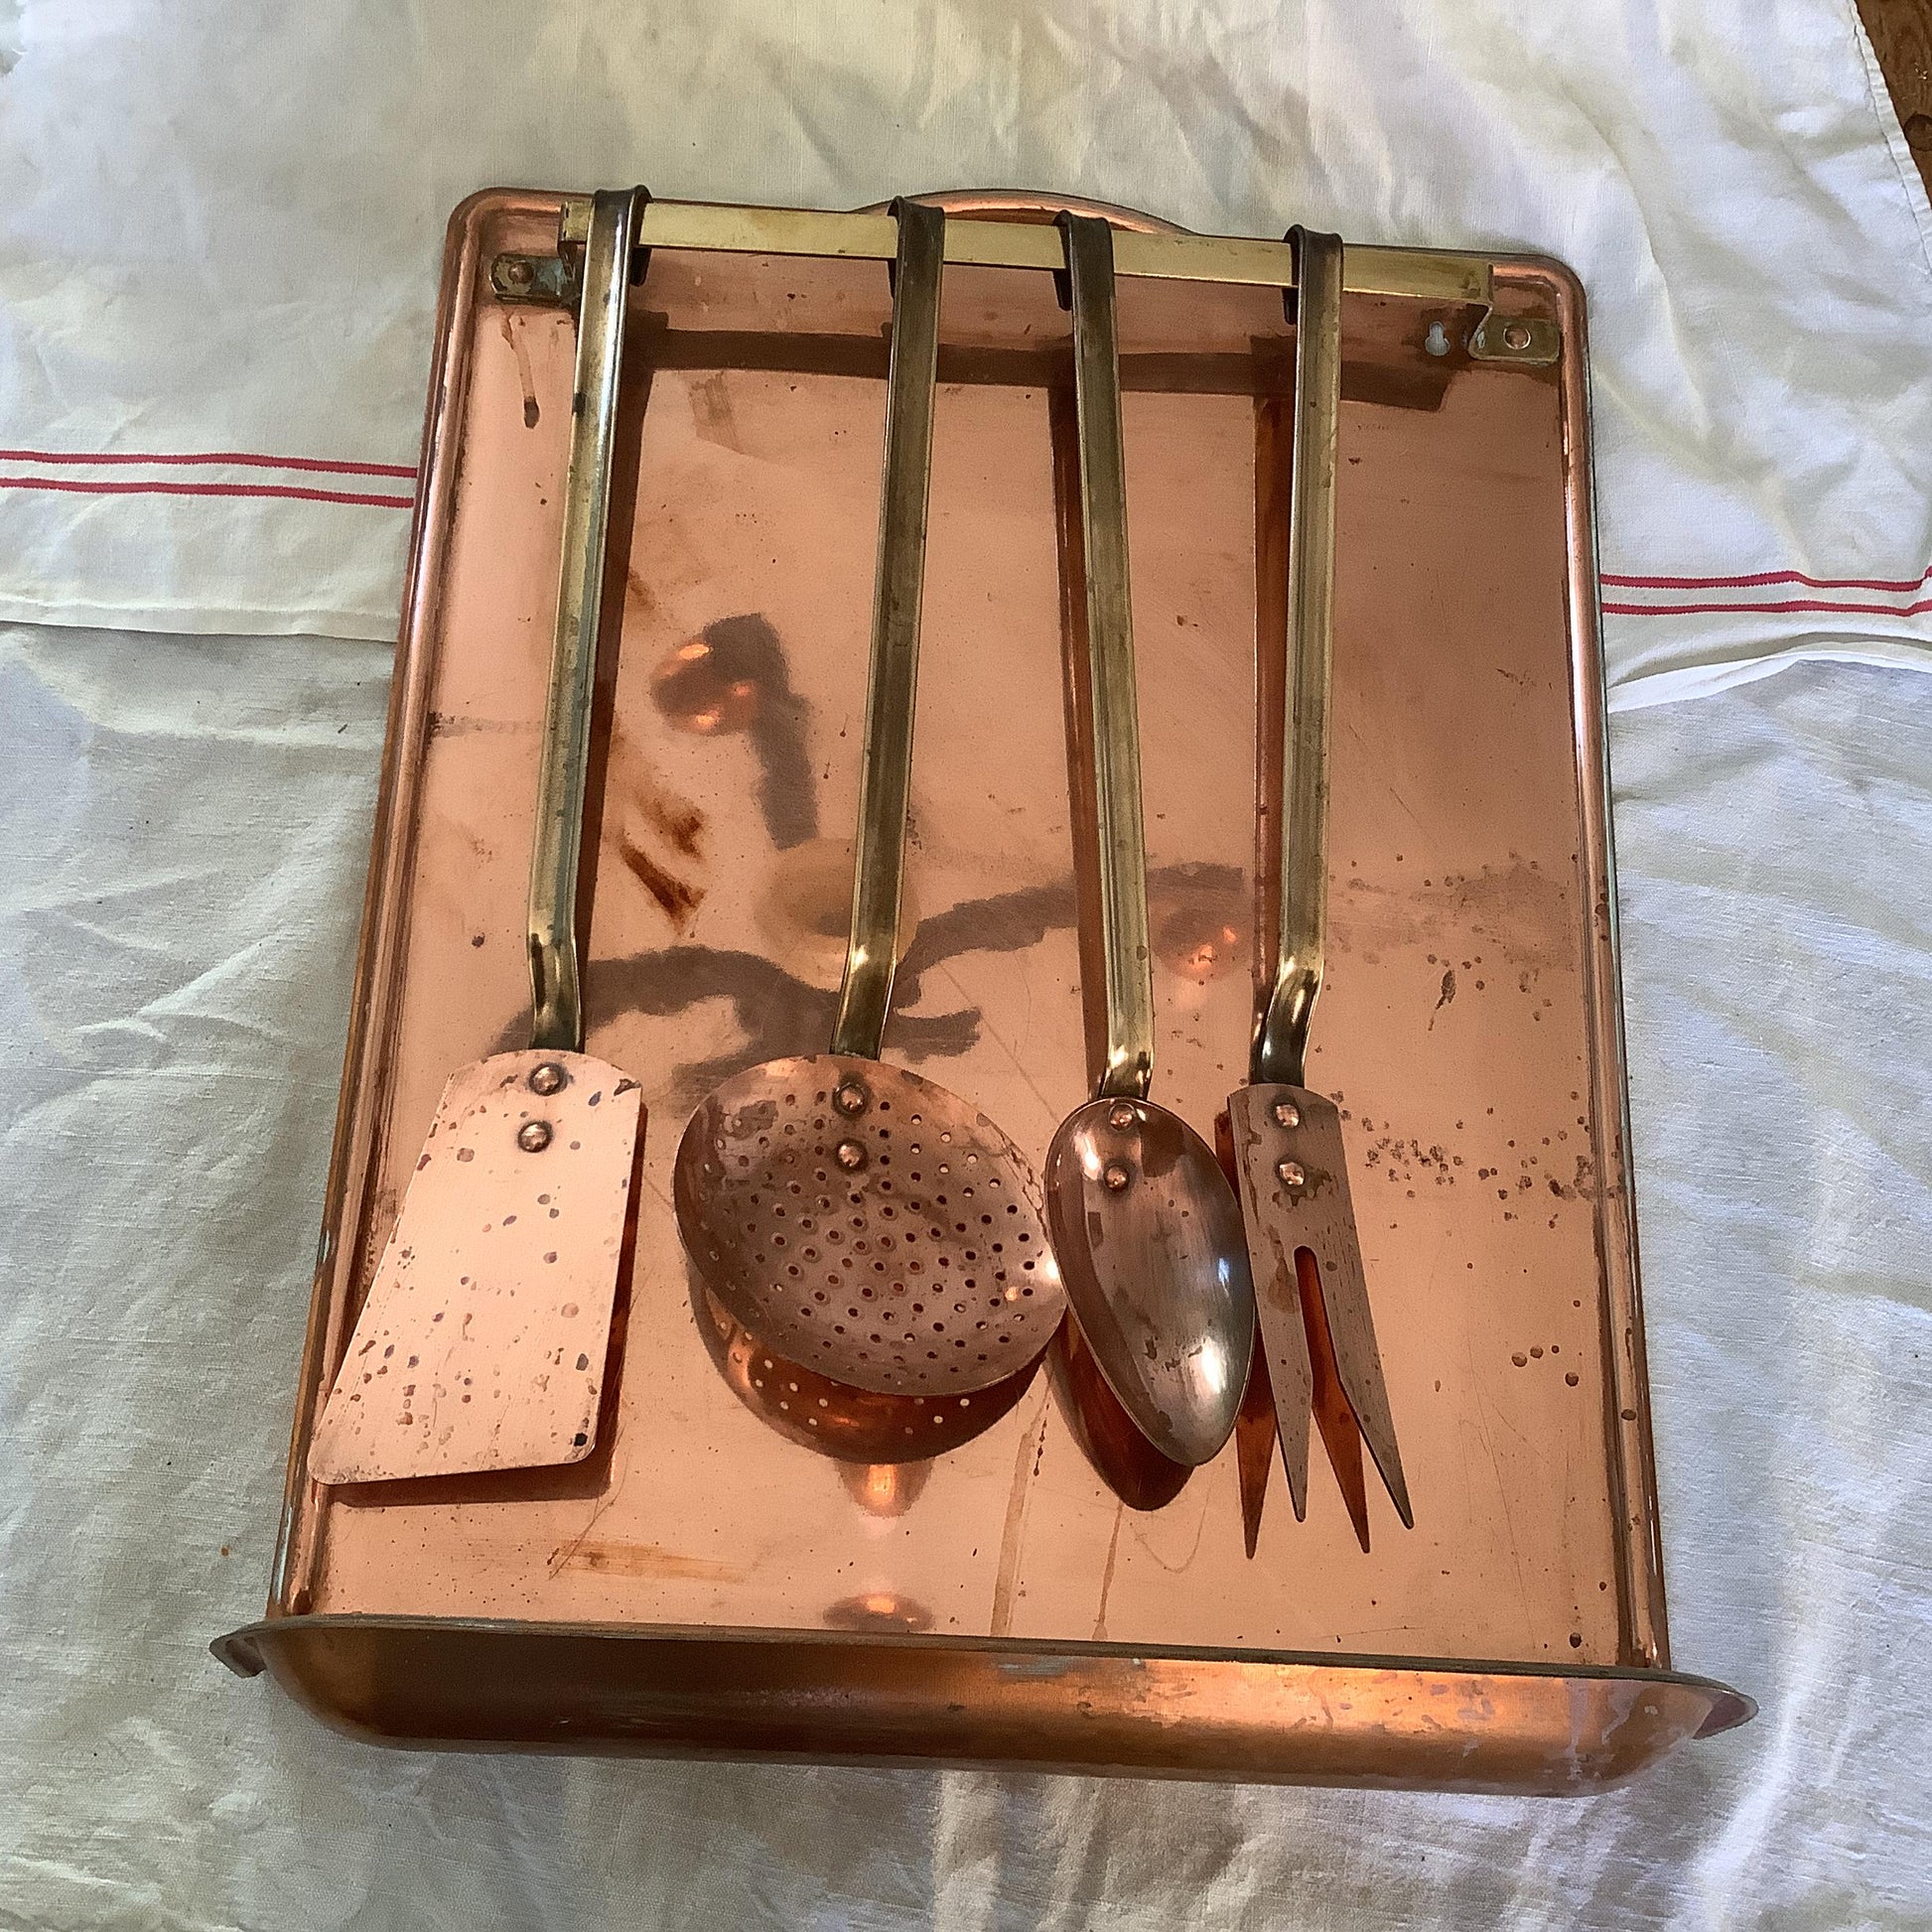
214 1592 1756 1797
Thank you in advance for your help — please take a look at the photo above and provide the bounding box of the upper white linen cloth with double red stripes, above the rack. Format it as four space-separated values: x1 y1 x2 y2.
0 0 1932 701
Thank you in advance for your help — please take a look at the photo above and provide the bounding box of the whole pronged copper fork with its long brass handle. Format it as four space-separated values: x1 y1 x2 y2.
1227 228 1414 1548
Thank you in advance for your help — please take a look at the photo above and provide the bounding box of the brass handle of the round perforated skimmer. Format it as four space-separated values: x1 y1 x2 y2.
833 201 947 1060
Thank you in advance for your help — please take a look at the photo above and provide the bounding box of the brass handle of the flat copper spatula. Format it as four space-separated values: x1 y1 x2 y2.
529 188 647 1053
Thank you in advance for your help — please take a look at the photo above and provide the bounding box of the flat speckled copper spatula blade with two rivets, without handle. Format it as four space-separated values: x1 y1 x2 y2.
309 1049 643 1484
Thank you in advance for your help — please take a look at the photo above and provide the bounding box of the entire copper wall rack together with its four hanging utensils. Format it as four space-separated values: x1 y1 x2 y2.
212 190 1750 1793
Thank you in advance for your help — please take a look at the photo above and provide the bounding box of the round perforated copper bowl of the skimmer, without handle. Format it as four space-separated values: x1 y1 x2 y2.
674 1053 1064 1395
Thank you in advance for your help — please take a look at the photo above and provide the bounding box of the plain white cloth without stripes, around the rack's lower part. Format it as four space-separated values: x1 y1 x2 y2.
0 629 1932 1932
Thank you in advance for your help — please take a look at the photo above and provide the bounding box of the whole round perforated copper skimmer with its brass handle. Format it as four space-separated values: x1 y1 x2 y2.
672 201 1064 1397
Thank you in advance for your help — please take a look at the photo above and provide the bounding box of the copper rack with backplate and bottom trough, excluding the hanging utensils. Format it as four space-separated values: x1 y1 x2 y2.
214 192 1752 1793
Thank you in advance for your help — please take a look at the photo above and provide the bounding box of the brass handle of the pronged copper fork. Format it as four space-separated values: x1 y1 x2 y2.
1248 228 1342 1086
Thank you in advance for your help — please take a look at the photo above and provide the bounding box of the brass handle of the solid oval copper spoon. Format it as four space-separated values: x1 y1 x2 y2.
1058 208 1154 1099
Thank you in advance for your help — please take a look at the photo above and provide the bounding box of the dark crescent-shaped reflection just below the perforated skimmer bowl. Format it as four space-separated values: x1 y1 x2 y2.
692 1287 1039 1460
